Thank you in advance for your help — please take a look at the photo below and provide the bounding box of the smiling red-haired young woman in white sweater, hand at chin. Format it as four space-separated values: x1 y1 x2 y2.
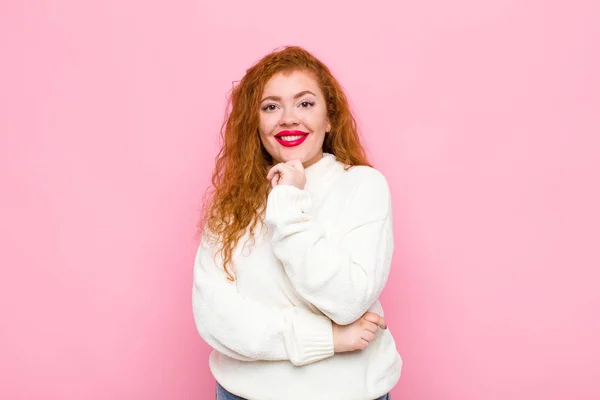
192 47 402 400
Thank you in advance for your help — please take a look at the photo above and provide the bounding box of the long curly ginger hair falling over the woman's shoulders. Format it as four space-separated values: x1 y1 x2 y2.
198 46 371 280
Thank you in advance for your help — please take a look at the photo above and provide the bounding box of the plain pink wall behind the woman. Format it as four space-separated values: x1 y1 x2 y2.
0 0 600 400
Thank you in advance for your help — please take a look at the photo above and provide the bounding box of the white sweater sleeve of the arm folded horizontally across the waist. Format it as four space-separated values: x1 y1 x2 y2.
192 233 334 366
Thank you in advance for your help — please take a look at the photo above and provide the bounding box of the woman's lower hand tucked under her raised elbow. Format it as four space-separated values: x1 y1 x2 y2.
332 312 387 353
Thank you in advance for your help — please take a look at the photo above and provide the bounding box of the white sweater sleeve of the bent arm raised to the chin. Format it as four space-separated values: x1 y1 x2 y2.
265 168 394 325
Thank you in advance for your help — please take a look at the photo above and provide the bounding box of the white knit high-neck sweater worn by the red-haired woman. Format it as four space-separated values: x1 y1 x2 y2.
192 153 402 400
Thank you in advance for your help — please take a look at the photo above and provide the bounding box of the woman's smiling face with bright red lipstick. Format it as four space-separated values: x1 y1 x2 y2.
258 71 331 167
